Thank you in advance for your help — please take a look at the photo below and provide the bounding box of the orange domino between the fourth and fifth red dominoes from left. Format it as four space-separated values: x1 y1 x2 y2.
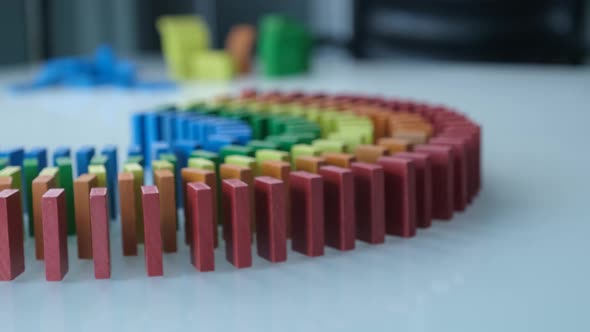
154 169 176 252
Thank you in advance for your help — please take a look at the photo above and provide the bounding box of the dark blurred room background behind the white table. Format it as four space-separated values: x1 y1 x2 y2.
0 0 590 65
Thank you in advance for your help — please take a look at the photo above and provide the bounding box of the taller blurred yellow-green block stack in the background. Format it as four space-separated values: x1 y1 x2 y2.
156 15 209 80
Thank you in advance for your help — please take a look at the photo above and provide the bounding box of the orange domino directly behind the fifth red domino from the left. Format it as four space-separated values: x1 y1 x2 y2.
181 168 220 248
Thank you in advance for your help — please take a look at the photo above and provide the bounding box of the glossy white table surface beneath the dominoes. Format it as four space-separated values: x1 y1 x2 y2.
0 57 590 332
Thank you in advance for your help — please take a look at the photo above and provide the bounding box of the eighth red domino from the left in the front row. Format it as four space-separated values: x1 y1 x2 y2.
289 171 324 257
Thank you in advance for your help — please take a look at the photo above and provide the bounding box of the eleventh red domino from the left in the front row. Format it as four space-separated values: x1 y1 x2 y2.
378 157 416 237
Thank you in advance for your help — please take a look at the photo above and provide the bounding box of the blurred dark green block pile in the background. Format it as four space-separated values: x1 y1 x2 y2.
258 15 311 77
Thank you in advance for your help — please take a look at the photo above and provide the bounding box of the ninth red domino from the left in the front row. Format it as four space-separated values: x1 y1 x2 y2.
319 166 356 250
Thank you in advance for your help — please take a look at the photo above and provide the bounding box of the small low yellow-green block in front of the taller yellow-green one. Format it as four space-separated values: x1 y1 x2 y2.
190 50 236 81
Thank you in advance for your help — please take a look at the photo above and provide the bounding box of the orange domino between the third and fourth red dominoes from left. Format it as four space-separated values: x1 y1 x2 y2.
118 172 137 256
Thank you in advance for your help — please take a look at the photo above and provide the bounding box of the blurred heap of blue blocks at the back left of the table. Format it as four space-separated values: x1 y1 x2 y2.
11 44 175 92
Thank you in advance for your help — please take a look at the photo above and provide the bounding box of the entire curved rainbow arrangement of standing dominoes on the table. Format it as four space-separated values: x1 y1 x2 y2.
0 90 481 280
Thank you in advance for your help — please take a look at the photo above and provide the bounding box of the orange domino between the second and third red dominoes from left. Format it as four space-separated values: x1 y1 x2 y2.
74 174 97 259
